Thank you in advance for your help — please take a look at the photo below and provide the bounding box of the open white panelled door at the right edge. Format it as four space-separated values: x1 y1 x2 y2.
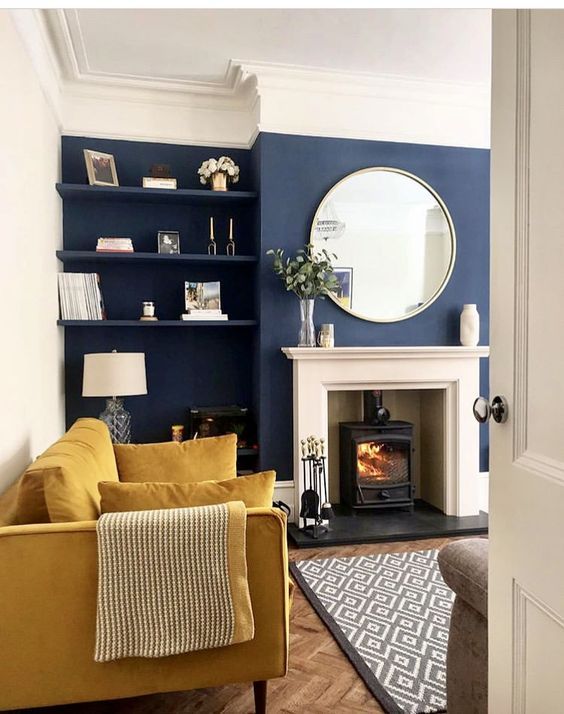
489 10 564 714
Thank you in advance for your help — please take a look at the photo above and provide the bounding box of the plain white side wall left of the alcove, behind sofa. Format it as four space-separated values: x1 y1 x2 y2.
0 10 64 492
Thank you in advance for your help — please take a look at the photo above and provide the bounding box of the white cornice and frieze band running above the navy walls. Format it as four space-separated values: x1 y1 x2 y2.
13 10 489 147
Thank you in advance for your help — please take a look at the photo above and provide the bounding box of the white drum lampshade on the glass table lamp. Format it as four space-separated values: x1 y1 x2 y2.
82 352 147 397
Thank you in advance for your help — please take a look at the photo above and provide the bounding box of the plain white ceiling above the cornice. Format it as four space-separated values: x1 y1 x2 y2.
47 9 491 85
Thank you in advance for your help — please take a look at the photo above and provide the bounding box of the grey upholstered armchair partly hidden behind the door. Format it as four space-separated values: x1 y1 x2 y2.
438 538 488 714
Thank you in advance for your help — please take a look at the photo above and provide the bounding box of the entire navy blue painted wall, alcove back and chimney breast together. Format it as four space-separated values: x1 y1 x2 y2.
62 133 489 480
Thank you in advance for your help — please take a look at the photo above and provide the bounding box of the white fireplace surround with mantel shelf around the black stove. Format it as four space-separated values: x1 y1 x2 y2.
282 347 489 516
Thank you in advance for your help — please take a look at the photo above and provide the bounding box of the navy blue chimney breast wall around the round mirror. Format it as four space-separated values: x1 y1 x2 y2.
256 133 489 479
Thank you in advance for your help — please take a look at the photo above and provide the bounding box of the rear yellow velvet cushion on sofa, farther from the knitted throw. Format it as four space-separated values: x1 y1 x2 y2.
114 434 237 483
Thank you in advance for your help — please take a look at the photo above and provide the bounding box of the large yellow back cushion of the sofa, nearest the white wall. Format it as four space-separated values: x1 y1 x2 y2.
17 419 118 523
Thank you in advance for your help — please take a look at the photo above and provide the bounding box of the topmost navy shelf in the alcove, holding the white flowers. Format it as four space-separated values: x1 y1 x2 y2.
57 183 258 205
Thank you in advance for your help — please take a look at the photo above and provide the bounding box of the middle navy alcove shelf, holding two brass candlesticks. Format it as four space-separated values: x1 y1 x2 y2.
57 250 258 265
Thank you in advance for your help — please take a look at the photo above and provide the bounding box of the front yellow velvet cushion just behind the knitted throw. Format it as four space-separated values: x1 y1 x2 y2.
98 471 276 513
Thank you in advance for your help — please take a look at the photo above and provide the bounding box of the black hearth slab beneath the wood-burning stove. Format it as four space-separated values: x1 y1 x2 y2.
288 501 488 548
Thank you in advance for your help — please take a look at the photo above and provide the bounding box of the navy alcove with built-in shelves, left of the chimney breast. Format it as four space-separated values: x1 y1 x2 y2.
56 137 260 456
